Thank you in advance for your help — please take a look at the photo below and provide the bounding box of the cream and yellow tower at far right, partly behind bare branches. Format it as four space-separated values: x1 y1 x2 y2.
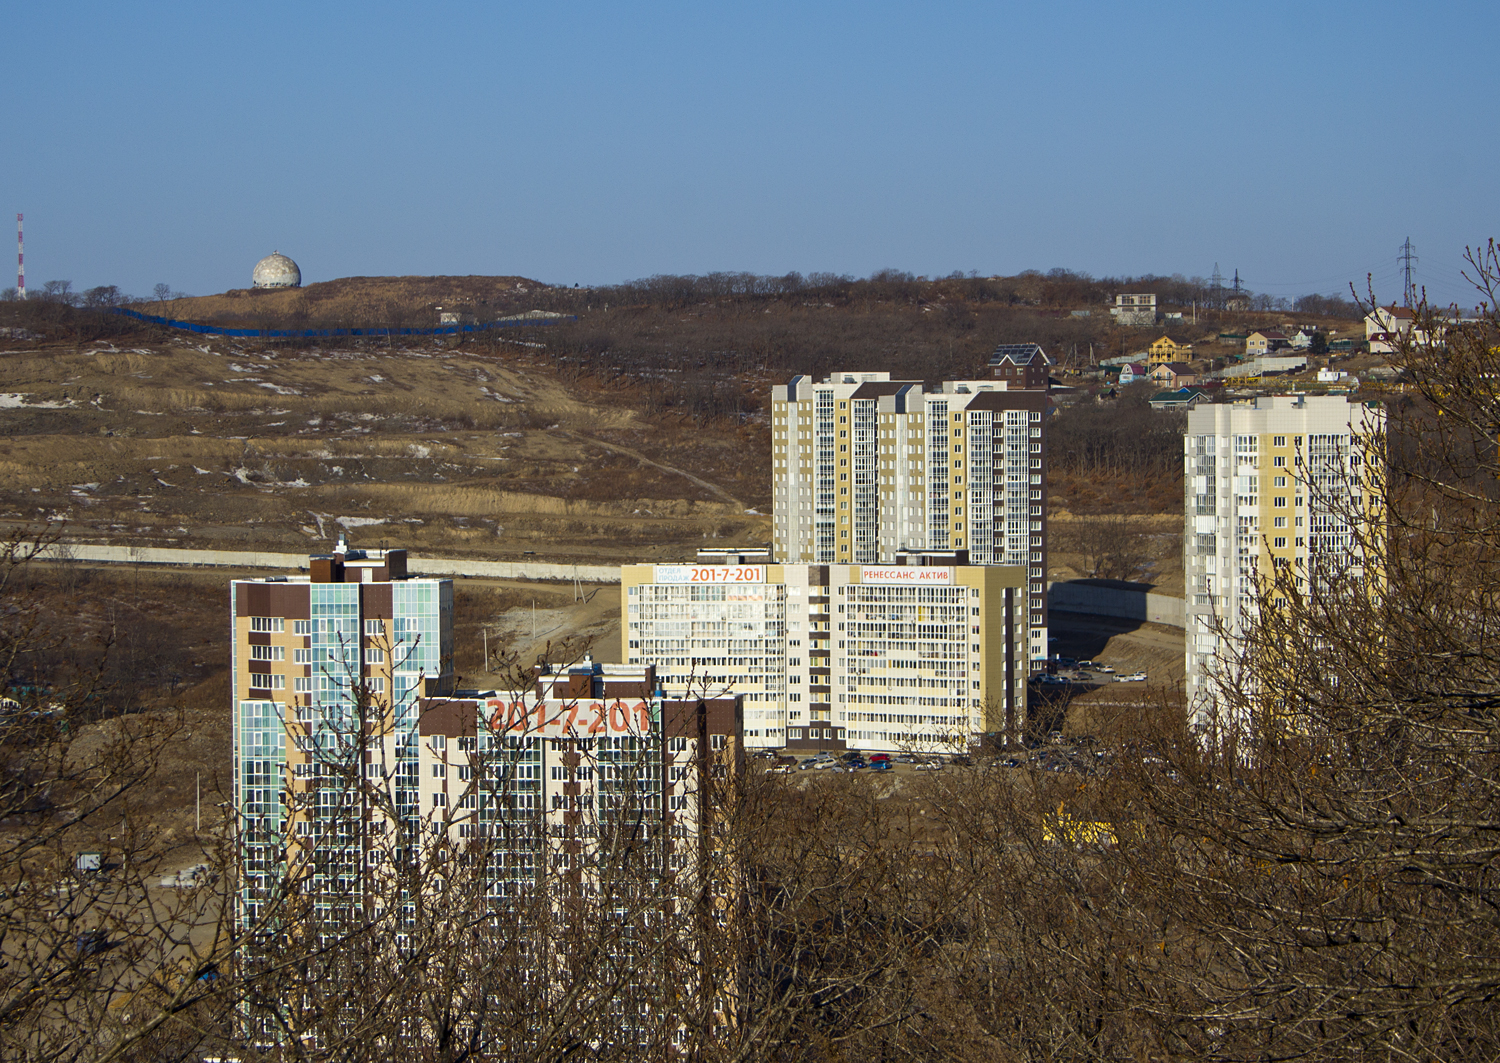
1182 394 1385 727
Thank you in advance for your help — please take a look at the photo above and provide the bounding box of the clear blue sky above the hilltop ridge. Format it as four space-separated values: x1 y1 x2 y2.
0 0 1500 304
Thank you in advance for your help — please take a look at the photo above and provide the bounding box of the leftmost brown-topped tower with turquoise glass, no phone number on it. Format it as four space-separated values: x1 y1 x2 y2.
230 540 453 924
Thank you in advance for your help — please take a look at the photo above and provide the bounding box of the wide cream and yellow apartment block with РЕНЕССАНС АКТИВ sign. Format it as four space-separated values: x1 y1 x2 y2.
621 552 1029 751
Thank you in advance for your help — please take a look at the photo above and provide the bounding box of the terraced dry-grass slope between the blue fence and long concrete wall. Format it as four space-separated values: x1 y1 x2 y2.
0 335 770 562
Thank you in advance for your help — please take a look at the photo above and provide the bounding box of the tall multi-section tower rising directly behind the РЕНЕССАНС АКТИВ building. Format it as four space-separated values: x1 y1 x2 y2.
771 367 1049 661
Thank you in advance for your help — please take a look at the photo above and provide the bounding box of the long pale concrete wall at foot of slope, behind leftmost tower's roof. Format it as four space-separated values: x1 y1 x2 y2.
42 543 620 583
